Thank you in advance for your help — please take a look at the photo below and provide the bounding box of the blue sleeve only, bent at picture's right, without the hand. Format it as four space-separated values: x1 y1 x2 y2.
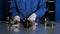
36 0 46 17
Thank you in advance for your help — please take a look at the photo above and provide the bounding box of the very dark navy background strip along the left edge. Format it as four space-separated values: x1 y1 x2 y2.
0 0 8 21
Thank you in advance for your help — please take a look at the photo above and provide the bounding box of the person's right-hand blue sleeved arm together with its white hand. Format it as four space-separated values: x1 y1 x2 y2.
28 0 46 21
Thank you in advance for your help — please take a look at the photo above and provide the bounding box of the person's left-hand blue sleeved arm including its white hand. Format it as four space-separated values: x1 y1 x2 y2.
10 0 20 21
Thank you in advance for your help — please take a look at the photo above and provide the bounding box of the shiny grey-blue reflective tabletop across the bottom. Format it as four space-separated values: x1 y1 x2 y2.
0 22 60 34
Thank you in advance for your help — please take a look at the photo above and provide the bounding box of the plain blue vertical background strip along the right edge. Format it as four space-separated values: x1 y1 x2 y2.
55 0 60 22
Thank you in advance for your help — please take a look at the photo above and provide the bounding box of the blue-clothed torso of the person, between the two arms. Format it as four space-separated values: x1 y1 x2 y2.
16 0 40 17
